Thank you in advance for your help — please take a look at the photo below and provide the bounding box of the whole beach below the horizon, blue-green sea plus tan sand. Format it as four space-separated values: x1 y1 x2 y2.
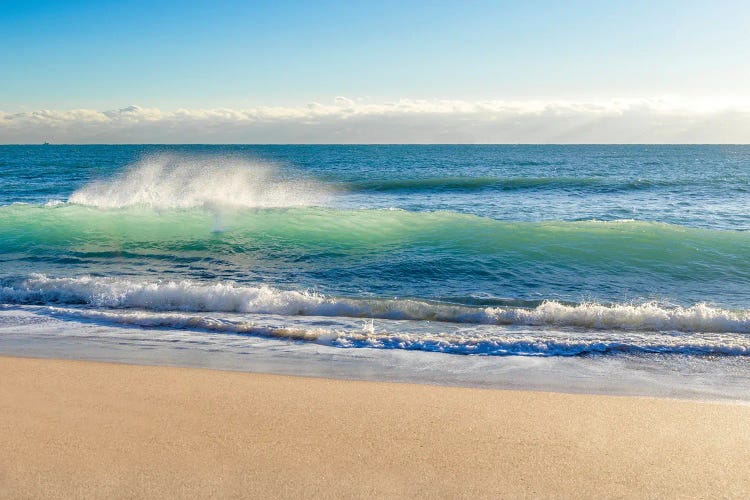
0 144 750 498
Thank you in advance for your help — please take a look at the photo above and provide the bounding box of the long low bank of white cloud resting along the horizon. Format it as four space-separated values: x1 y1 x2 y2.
0 96 750 144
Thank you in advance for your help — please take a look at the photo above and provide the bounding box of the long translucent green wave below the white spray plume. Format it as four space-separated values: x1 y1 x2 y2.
0 204 750 283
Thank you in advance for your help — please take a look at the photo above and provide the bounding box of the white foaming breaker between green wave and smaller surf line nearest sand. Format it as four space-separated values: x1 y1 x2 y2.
0 275 750 333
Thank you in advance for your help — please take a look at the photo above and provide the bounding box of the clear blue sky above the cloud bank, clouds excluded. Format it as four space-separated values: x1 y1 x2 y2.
0 0 750 143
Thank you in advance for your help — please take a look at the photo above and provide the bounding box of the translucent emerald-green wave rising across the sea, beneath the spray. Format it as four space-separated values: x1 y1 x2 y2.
0 204 750 268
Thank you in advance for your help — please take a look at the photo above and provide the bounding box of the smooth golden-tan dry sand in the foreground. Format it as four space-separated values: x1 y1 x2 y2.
0 357 750 498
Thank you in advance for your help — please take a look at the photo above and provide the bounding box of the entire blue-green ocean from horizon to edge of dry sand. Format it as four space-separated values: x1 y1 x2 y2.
0 145 750 400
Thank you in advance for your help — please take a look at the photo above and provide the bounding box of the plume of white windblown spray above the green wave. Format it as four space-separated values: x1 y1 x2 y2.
68 154 330 209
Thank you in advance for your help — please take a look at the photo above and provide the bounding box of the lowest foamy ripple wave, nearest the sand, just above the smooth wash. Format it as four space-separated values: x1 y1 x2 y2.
10 306 750 357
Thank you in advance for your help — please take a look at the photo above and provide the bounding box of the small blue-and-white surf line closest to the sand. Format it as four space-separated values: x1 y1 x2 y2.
0 298 750 358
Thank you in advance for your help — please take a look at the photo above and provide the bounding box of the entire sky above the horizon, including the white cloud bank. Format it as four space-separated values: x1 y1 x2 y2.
0 0 750 143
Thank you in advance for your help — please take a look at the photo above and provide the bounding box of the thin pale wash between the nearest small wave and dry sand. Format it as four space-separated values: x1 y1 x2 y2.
5 309 750 404
